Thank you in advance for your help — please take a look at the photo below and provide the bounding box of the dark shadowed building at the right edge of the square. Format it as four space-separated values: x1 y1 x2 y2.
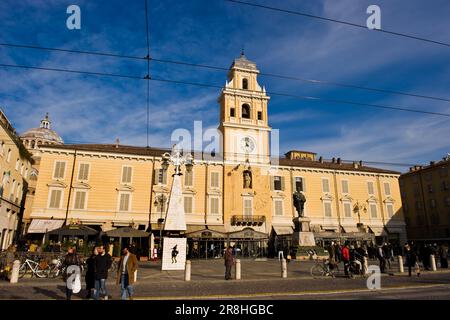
400 156 450 241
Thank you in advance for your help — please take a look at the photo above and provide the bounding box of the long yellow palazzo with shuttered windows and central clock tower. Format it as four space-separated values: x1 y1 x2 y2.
31 55 406 256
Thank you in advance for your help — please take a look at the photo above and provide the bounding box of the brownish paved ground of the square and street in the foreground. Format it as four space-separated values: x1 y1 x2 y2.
0 259 450 299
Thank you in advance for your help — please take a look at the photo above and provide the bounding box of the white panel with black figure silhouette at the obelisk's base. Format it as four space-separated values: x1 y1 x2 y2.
162 237 186 271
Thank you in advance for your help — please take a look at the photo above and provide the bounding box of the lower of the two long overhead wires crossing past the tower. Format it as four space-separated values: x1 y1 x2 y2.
0 63 450 117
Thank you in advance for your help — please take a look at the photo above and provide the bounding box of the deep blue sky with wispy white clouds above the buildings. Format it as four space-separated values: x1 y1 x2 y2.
0 0 450 170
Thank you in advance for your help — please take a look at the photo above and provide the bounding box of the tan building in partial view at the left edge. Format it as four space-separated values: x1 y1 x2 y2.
0 109 32 250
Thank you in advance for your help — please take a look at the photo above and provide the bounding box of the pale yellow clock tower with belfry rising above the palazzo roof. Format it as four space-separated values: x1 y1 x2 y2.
219 52 272 164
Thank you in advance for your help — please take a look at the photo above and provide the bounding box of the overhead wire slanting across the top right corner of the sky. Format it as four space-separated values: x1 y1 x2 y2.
225 0 450 47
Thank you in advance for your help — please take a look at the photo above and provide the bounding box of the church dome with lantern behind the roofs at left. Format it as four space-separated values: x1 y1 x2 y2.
20 114 64 150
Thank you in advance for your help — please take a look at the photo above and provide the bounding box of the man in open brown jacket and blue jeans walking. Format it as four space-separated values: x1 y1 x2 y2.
117 247 138 300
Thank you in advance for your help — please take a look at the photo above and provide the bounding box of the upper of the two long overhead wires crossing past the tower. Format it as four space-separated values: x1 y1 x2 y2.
0 43 450 102
